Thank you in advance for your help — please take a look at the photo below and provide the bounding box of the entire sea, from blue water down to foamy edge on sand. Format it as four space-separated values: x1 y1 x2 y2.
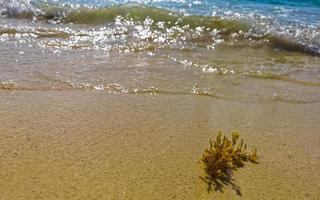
0 0 320 103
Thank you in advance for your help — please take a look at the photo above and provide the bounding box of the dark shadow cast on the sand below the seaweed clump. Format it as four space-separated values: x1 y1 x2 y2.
199 170 242 196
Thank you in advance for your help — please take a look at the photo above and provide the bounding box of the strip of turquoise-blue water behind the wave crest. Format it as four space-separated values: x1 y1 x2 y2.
42 0 320 23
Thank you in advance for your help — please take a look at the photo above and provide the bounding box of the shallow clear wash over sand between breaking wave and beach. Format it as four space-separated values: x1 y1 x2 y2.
0 40 320 103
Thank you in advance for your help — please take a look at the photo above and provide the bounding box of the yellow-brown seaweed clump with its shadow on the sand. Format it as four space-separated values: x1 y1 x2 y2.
200 131 258 195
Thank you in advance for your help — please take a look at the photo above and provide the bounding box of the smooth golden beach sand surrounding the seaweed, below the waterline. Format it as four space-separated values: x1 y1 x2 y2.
0 91 320 200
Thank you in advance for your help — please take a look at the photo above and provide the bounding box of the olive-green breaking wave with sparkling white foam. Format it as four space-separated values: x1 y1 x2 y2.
0 0 320 56
